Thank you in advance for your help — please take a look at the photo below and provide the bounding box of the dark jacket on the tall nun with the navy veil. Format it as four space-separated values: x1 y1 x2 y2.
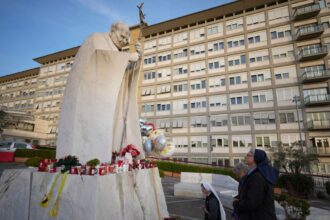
236 169 276 220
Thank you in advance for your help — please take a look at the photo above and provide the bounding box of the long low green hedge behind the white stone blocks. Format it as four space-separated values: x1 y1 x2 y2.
157 161 237 179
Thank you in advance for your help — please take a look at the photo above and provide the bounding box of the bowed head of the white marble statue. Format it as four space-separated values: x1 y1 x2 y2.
110 22 130 49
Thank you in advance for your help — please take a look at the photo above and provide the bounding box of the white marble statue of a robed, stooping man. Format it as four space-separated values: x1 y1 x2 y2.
56 23 144 162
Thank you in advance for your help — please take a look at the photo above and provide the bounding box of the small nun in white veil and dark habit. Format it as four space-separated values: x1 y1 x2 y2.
201 182 226 220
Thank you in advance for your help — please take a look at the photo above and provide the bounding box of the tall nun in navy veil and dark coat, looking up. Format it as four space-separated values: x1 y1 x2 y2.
233 149 278 220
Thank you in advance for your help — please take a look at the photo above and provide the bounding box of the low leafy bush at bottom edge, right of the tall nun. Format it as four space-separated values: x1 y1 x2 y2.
275 193 310 219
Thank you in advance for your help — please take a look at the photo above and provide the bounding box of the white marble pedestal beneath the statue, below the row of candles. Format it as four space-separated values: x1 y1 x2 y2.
0 168 168 220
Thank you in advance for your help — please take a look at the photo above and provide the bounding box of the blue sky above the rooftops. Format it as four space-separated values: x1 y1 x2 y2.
0 0 233 77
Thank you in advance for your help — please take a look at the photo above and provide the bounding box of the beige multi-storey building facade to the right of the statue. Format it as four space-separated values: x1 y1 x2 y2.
140 0 330 173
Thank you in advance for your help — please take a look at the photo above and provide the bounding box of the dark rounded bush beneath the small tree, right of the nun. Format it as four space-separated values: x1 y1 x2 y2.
276 174 314 198
